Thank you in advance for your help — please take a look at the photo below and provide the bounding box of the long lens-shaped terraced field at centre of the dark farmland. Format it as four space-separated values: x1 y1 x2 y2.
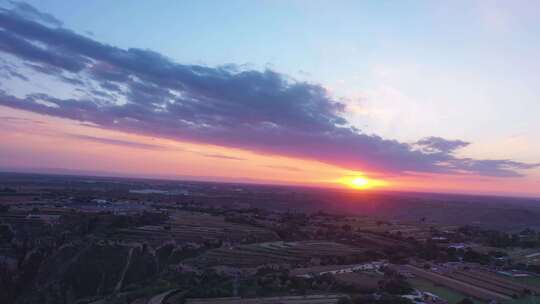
195 241 365 267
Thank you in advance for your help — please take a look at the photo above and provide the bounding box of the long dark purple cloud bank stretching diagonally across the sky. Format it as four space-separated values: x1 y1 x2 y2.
0 2 540 177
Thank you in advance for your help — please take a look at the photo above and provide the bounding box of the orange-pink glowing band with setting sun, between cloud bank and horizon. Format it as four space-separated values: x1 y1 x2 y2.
0 107 540 197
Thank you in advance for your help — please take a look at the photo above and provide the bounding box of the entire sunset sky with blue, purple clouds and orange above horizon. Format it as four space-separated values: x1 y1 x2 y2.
0 0 540 196
